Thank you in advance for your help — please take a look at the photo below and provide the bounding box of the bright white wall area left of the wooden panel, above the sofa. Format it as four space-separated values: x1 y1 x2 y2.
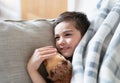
0 0 21 19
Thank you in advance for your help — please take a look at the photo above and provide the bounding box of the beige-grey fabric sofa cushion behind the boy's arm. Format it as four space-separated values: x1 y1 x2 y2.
0 19 54 83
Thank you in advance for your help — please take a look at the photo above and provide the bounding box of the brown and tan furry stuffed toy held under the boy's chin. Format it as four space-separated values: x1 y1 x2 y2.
44 54 72 83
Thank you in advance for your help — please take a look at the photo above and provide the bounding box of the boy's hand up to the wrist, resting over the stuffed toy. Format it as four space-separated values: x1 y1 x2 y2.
27 46 57 71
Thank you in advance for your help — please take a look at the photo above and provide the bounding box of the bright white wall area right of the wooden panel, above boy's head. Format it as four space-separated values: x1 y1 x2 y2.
68 0 99 18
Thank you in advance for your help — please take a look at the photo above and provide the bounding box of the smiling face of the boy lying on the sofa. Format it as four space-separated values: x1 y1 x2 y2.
55 21 81 58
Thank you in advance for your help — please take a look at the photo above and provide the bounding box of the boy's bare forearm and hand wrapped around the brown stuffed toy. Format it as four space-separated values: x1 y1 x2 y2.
27 46 57 83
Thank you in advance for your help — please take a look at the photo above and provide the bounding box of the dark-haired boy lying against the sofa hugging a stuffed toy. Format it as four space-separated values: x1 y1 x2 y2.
27 12 90 83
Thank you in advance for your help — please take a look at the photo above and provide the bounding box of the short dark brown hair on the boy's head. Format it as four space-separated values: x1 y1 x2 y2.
54 11 90 36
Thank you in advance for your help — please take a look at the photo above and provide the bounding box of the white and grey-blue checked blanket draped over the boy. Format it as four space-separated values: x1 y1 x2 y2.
71 0 120 83
